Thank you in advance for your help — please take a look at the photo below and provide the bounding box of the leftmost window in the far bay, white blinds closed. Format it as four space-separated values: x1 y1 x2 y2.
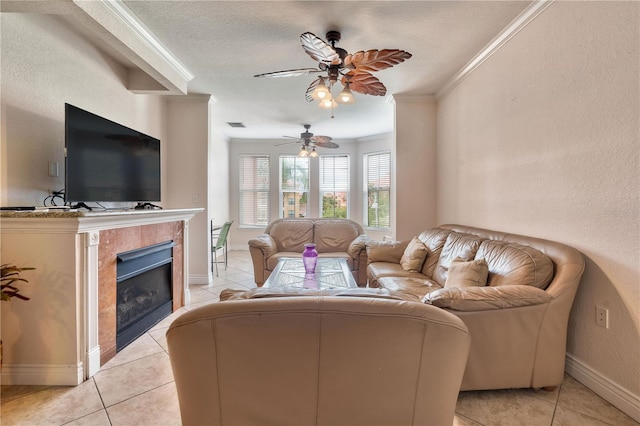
240 155 269 226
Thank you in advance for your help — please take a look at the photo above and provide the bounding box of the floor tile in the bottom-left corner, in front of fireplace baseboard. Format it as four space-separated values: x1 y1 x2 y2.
0 380 104 426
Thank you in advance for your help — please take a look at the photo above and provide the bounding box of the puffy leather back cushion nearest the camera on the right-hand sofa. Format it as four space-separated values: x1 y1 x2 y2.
476 240 553 289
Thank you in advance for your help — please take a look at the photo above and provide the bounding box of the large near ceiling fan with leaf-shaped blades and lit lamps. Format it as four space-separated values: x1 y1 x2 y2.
254 31 411 108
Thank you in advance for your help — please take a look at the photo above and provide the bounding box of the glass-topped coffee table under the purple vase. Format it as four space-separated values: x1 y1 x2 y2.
262 257 358 290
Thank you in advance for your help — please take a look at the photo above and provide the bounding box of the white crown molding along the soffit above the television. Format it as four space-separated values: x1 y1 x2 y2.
99 0 195 81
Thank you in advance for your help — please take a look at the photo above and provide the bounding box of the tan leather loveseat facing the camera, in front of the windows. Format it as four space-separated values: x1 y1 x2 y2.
249 218 368 287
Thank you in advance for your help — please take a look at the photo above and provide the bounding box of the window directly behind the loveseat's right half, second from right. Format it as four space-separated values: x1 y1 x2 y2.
320 155 349 218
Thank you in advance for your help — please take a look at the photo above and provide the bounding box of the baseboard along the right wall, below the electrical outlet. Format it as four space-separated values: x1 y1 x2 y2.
565 354 640 422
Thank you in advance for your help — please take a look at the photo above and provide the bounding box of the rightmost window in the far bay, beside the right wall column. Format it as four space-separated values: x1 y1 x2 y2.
364 152 391 228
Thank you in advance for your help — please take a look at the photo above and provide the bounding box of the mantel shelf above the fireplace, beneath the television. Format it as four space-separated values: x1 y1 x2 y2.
0 208 204 233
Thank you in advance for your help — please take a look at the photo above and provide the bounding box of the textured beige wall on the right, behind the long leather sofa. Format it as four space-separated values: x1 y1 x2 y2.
437 2 640 400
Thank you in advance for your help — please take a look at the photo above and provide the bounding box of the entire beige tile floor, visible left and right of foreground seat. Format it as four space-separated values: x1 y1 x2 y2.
0 251 639 426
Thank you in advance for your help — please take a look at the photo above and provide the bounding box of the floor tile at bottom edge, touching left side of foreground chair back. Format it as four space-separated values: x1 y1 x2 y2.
107 382 181 426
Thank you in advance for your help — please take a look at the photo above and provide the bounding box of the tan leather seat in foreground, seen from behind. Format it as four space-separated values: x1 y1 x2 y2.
167 296 470 426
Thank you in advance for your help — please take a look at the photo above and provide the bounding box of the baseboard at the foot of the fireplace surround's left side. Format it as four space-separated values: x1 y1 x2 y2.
2 362 84 386
